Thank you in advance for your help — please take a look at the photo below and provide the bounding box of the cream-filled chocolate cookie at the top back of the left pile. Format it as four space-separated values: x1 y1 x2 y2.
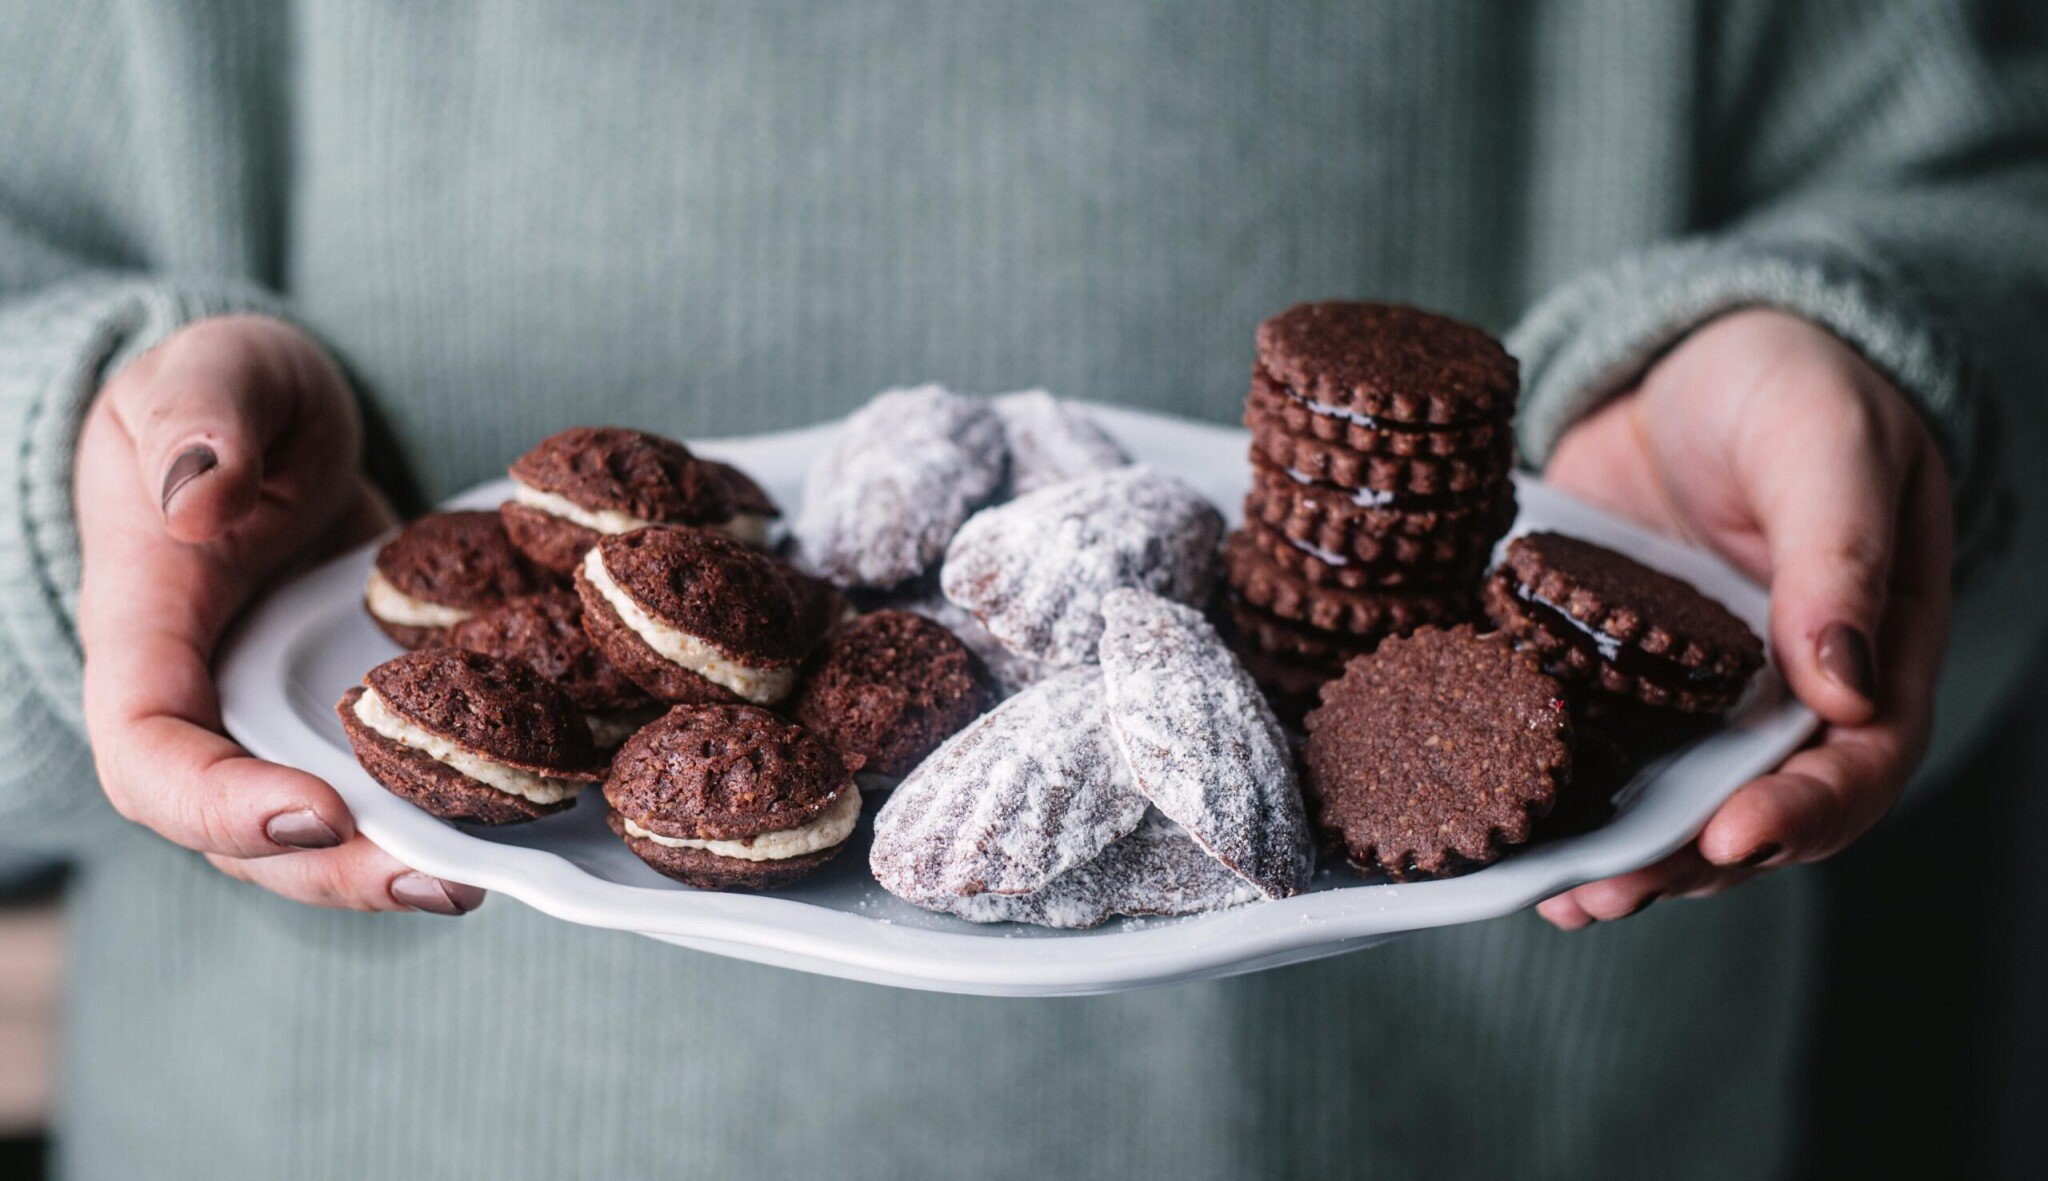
500 426 778 575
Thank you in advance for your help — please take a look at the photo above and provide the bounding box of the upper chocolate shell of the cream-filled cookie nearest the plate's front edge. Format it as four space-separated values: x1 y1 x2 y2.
604 706 852 839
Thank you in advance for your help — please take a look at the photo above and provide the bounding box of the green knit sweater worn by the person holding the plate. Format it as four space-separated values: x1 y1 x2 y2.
0 0 2048 1179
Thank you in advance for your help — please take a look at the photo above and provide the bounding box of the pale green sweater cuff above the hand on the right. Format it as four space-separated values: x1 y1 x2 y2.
1507 225 1995 551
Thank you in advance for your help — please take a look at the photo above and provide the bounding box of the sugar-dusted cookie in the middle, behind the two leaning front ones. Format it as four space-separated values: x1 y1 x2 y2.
938 467 1223 665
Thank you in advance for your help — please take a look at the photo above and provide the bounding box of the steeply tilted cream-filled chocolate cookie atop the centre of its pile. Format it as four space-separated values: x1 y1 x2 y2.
575 526 815 704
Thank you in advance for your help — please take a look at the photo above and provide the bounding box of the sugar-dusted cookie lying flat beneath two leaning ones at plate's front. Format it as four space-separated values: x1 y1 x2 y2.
942 808 1260 927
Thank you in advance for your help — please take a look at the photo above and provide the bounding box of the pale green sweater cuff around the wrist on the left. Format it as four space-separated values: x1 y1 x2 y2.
0 274 274 845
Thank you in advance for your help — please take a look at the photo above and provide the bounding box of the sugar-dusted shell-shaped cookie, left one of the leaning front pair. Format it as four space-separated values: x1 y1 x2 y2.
870 667 1145 909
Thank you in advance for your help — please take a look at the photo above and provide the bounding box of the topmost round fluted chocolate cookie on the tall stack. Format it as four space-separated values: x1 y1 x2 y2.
1257 301 1522 430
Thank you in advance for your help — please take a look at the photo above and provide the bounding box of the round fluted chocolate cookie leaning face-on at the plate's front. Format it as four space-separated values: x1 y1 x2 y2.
1305 626 1571 880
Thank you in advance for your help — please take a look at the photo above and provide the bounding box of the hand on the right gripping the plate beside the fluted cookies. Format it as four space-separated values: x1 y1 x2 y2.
1538 309 1952 931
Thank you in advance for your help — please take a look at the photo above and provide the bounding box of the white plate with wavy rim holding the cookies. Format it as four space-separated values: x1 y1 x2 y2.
219 407 1815 995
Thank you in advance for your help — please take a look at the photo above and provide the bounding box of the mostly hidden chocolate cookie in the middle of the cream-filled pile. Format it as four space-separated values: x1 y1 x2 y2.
446 589 659 751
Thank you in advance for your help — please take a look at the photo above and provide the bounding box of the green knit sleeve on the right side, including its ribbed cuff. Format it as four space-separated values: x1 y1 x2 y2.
1509 2 2048 573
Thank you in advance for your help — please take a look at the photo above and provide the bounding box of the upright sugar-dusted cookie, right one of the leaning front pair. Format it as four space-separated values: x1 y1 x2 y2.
1102 589 1313 899
